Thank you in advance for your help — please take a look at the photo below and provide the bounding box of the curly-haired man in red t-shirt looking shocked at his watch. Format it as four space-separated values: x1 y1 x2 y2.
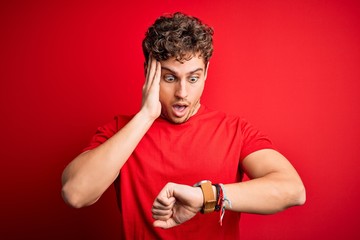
62 13 305 239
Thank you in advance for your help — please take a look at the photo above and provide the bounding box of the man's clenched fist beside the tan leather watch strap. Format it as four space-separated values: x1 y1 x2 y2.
151 183 203 229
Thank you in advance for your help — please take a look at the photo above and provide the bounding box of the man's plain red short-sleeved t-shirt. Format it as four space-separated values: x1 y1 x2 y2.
84 106 273 240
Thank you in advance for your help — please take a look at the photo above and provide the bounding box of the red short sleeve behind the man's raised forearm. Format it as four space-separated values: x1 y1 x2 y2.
82 116 131 152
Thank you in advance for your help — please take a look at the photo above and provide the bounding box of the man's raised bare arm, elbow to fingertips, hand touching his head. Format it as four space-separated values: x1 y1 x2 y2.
62 58 161 208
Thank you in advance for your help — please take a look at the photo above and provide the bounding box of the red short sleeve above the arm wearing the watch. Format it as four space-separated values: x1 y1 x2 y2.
240 119 275 160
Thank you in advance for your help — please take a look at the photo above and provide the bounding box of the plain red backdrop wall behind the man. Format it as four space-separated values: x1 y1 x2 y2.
0 0 360 239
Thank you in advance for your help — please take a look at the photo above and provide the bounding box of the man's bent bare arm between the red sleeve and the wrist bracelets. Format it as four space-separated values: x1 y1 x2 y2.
225 149 306 214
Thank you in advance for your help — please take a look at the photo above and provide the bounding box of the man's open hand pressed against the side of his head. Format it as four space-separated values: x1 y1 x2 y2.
142 55 161 119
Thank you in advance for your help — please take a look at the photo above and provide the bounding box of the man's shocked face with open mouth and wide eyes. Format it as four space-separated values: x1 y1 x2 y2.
160 56 207 123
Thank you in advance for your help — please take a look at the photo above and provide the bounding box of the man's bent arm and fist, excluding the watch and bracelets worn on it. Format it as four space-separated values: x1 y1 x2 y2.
152 149 306 228
